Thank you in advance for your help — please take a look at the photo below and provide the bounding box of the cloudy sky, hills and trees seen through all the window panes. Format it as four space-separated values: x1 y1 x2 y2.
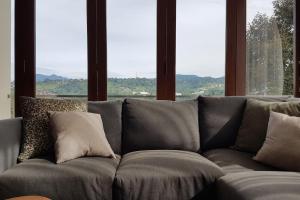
11 0 294 116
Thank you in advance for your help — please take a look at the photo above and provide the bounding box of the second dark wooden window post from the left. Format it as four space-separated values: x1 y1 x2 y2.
87 0 107 101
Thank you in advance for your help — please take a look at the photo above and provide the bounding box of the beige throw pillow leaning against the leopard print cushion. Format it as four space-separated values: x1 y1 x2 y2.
49 112 116 163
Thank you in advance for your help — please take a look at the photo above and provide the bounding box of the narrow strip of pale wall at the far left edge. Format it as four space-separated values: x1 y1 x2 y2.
0 0 11 119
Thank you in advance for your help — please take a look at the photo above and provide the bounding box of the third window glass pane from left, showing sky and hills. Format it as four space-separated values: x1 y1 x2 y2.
176 0 226 99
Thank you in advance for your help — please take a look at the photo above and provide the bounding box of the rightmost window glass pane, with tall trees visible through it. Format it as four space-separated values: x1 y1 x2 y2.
246 0 294 95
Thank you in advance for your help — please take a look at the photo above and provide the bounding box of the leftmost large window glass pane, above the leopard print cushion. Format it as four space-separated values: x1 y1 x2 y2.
36 0 87 98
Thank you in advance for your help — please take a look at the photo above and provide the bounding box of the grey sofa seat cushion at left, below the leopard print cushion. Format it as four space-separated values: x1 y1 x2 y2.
0 156 120 200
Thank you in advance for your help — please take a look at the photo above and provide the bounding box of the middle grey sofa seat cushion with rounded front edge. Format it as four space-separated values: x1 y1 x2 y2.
114 150 224 200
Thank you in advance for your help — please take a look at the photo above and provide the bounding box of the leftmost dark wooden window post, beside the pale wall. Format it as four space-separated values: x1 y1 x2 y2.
15 0 35 117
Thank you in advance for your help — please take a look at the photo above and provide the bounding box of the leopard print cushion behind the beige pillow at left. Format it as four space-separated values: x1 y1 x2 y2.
18 97 87 162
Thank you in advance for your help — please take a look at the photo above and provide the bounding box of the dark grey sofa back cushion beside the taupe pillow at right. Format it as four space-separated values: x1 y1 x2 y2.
198 96 246 151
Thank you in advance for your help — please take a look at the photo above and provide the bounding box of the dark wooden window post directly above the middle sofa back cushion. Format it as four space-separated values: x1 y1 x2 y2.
156 0 176 100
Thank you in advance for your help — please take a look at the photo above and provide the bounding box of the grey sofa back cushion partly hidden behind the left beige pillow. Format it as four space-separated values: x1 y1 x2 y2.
88 101 122 154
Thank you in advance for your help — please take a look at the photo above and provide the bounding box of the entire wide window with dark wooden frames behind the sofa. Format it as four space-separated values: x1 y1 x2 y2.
12 0 300 111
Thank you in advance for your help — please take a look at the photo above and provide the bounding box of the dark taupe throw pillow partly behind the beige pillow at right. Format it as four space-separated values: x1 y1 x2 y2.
234 99 300 153
